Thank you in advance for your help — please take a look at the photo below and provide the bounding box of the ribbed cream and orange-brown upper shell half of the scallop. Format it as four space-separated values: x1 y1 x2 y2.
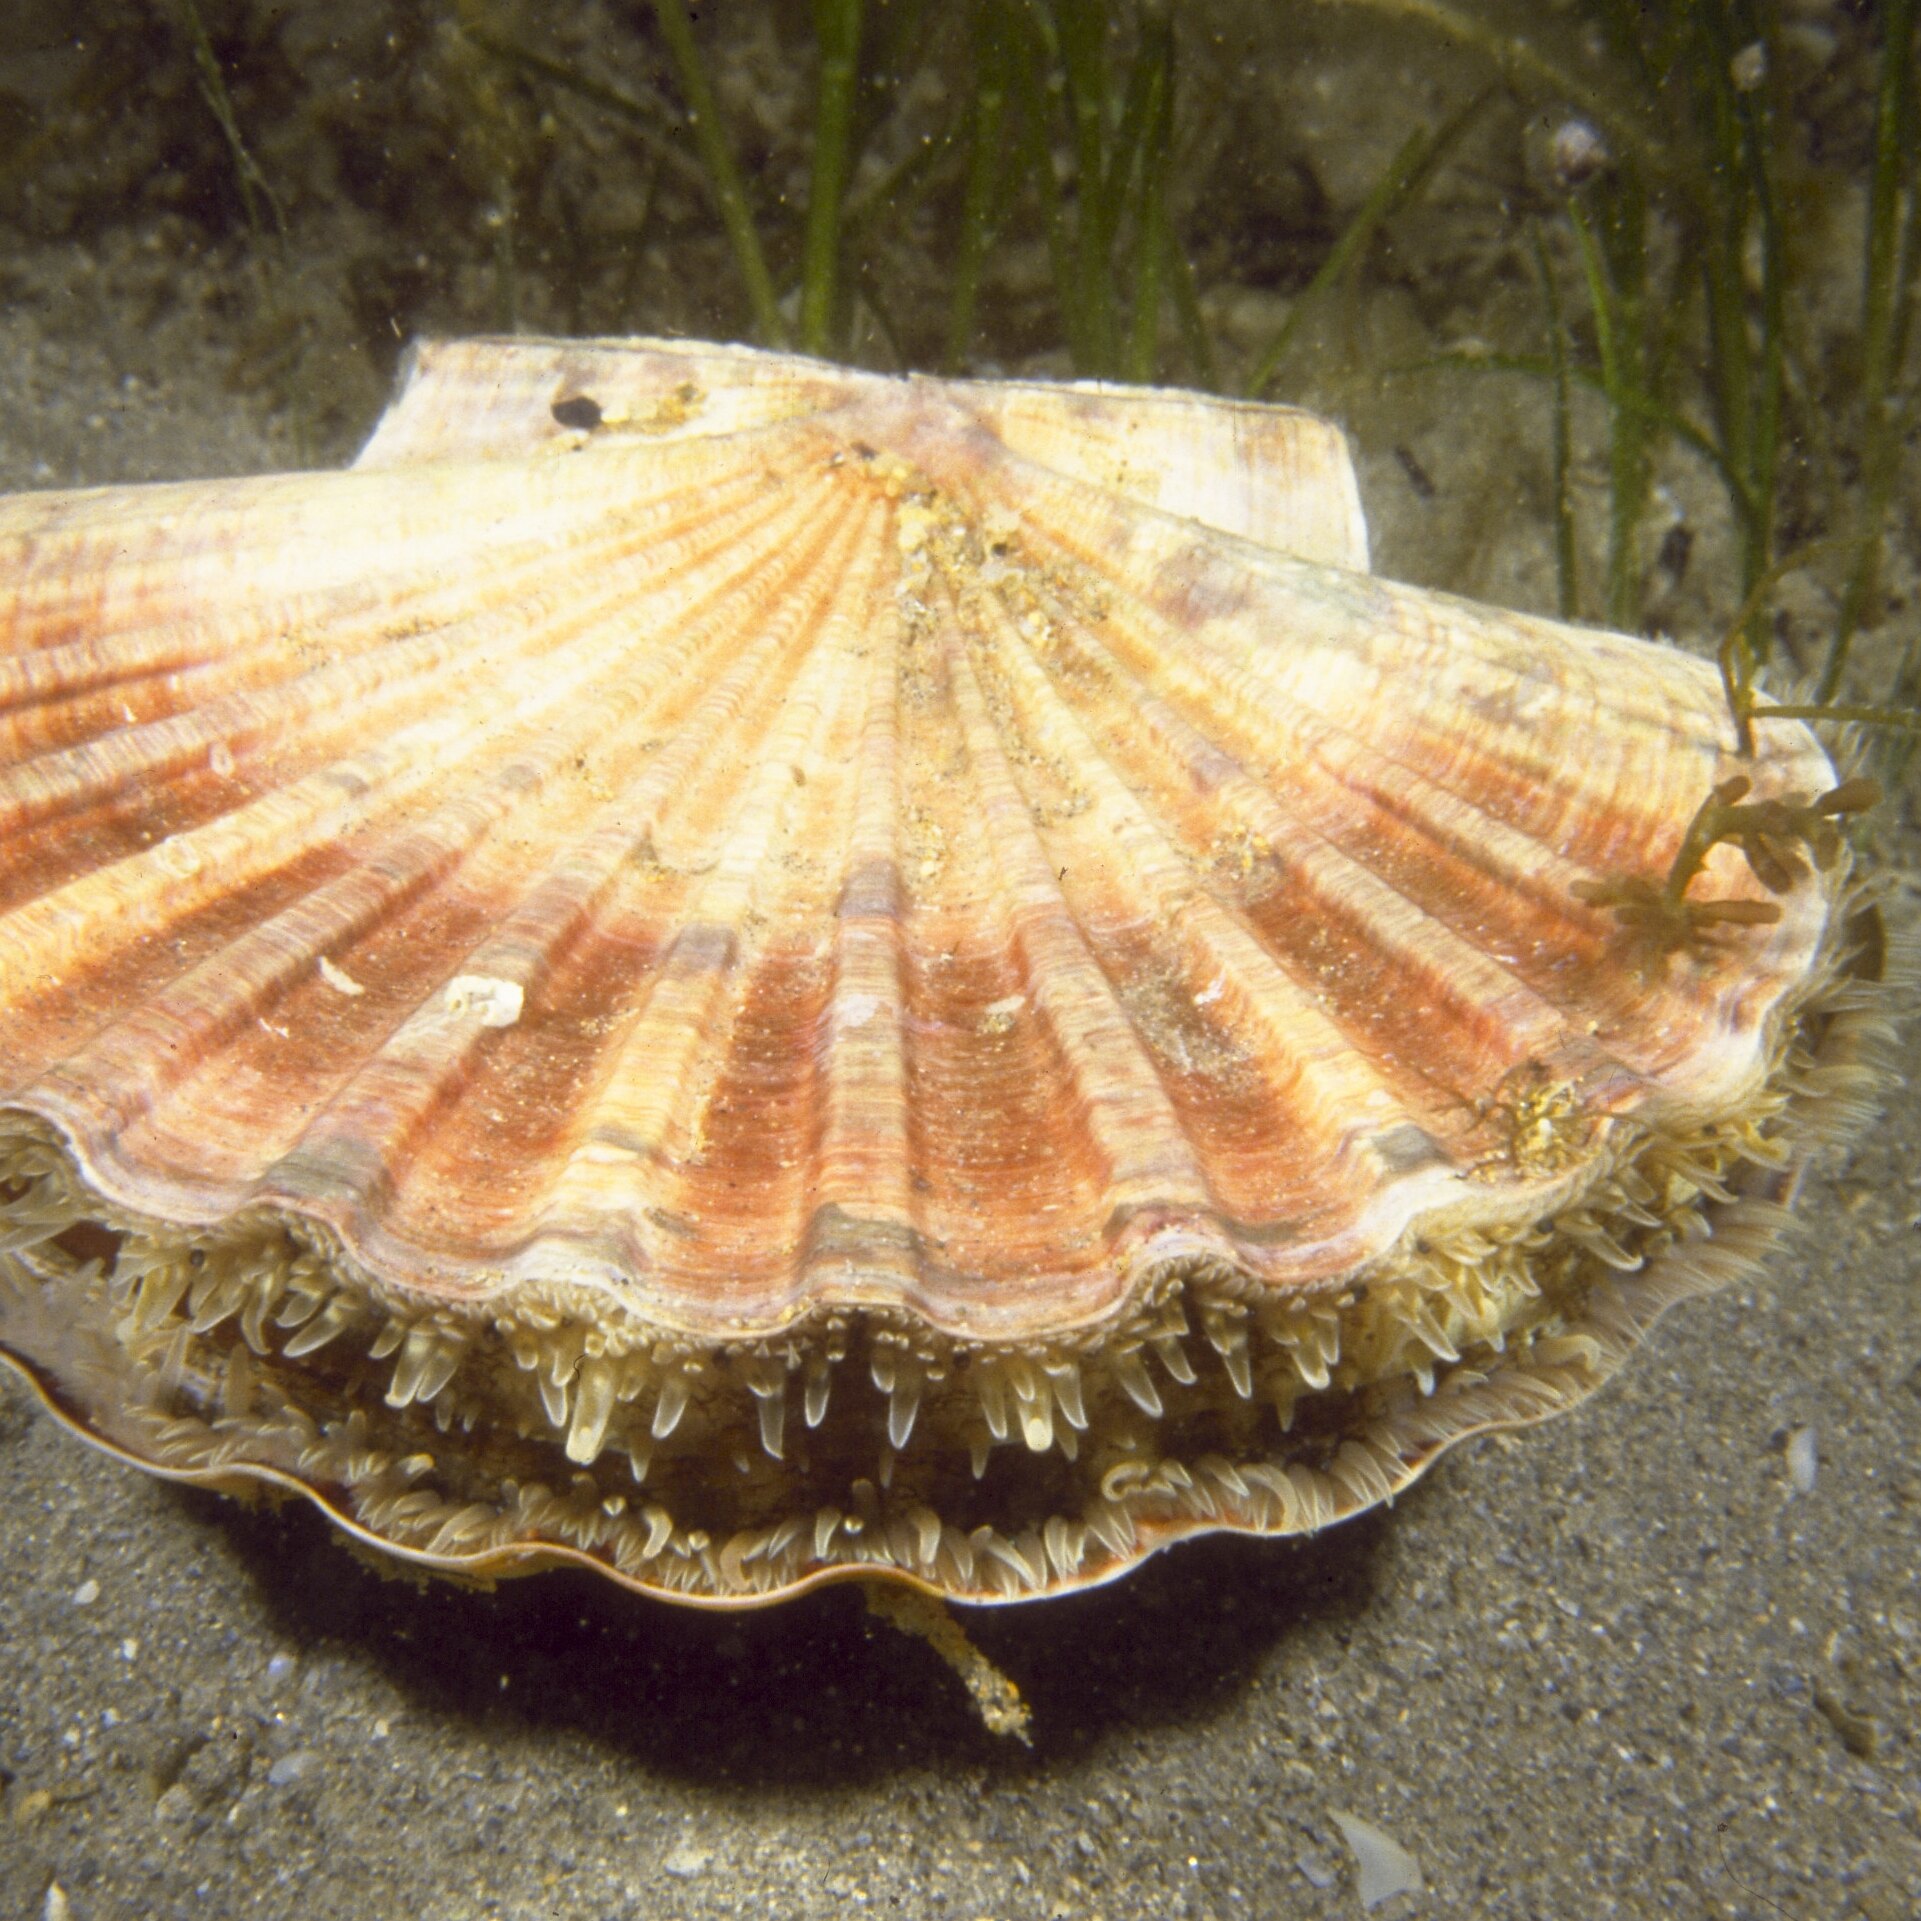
0 344 1833 1343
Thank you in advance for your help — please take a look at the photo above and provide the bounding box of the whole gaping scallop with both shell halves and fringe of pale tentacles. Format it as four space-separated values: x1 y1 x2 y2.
0 342 1875 1604
